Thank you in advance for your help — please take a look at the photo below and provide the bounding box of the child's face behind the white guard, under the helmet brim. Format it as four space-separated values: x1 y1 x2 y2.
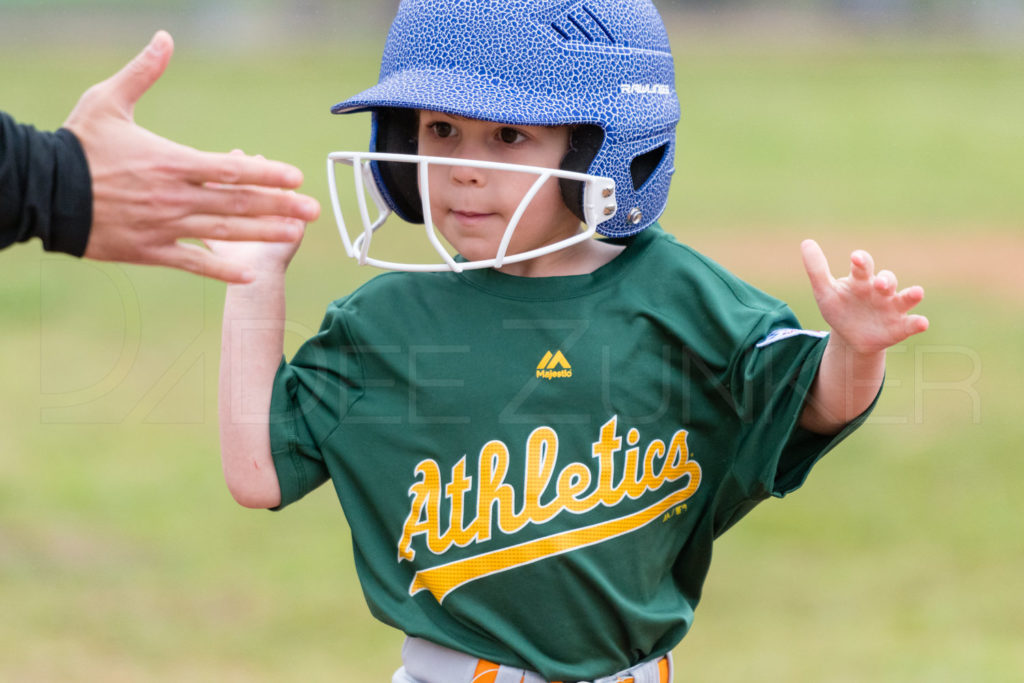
411 111 580 267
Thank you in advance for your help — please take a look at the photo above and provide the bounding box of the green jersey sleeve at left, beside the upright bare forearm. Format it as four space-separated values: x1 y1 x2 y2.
270 303 362 509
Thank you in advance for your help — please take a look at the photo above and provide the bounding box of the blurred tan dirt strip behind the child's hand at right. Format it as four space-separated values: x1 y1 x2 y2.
688 228 1024 308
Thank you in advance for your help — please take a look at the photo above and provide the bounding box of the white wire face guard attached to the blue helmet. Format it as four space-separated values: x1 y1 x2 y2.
327 152 615 272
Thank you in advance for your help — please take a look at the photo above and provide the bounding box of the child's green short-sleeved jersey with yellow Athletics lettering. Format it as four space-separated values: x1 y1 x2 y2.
270 225 872 680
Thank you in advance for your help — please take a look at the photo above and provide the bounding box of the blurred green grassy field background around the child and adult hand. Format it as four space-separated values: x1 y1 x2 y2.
0 0 1024 682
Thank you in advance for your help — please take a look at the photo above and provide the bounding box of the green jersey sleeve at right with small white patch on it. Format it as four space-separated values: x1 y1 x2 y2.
717 305 878 533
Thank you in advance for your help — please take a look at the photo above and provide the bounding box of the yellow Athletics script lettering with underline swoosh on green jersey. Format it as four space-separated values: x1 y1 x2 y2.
398 416 700 602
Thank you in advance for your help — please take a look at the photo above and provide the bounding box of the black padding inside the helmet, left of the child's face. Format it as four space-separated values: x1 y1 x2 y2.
373 108 423 223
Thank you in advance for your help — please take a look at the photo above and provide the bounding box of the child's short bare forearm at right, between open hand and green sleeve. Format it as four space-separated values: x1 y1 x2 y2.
800 333 886 434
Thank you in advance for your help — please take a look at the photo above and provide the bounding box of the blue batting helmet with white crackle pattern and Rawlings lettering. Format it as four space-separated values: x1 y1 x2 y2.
332 0 679 237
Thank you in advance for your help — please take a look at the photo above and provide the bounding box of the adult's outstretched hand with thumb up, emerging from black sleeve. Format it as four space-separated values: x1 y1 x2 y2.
65 31 319 283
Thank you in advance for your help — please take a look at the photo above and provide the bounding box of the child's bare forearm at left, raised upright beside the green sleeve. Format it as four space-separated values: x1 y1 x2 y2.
219 273 285 508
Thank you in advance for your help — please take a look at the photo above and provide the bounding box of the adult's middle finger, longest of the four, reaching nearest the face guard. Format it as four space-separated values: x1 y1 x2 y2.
181 185 319 222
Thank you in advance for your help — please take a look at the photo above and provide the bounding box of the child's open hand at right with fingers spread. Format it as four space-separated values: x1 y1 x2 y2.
801 240 928 353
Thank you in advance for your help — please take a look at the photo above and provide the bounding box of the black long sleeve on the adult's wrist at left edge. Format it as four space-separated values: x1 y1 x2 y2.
0 112 92 256
